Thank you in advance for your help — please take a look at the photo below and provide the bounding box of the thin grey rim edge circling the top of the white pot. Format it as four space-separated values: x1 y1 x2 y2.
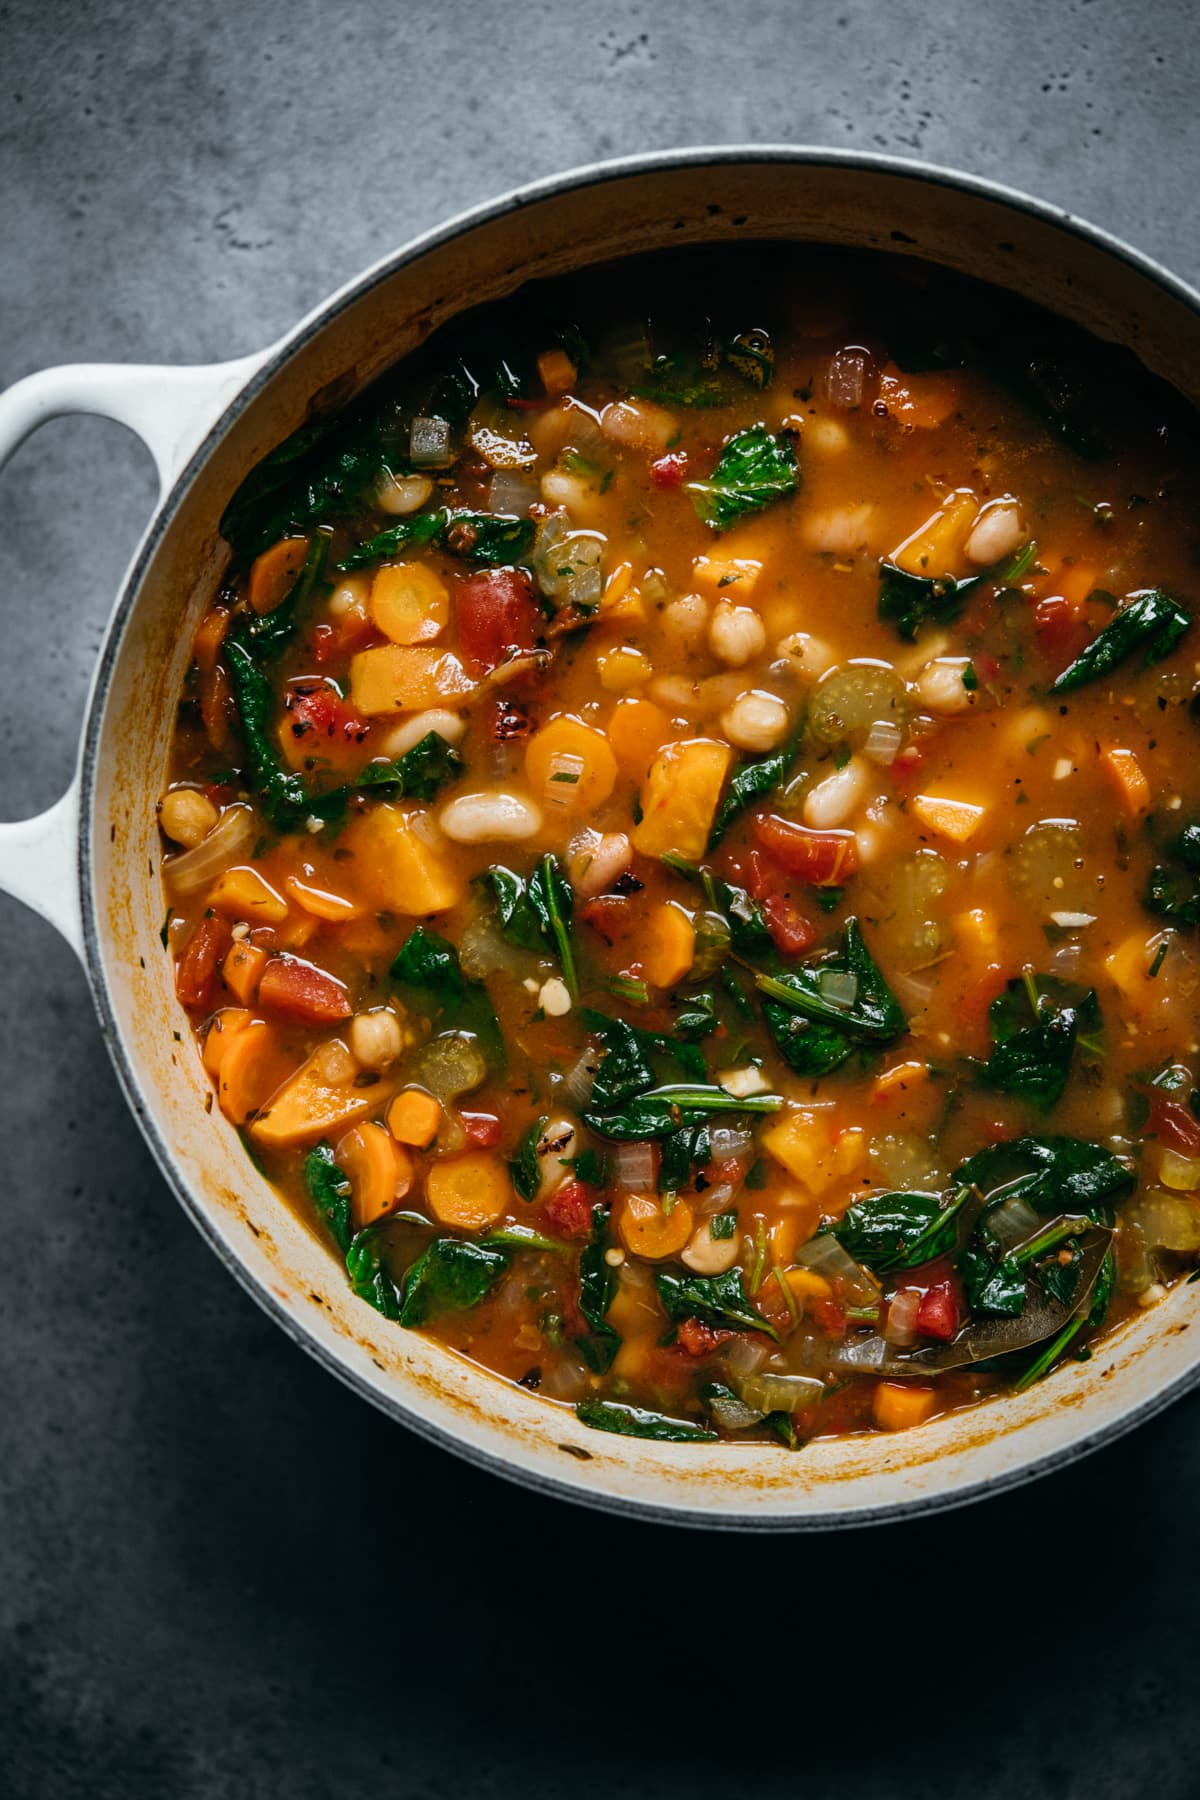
77 144 1200 1534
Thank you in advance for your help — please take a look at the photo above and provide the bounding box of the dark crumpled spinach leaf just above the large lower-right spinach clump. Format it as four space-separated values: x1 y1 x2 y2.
982 974 1103 1112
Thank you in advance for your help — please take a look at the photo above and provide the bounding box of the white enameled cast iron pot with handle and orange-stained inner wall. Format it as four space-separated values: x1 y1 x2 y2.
0 148 1200 1528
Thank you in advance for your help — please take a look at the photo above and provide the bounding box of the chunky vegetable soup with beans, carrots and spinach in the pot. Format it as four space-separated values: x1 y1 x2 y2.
158 247 1200 1447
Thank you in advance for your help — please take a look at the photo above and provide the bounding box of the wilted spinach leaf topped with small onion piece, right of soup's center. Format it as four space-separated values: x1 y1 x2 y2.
754 918 909 1075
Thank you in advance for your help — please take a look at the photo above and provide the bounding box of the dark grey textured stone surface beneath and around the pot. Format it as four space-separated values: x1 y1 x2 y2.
0 0 1200 1800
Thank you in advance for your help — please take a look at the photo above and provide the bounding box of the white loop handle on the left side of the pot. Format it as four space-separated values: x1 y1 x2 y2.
0 349 272 961
